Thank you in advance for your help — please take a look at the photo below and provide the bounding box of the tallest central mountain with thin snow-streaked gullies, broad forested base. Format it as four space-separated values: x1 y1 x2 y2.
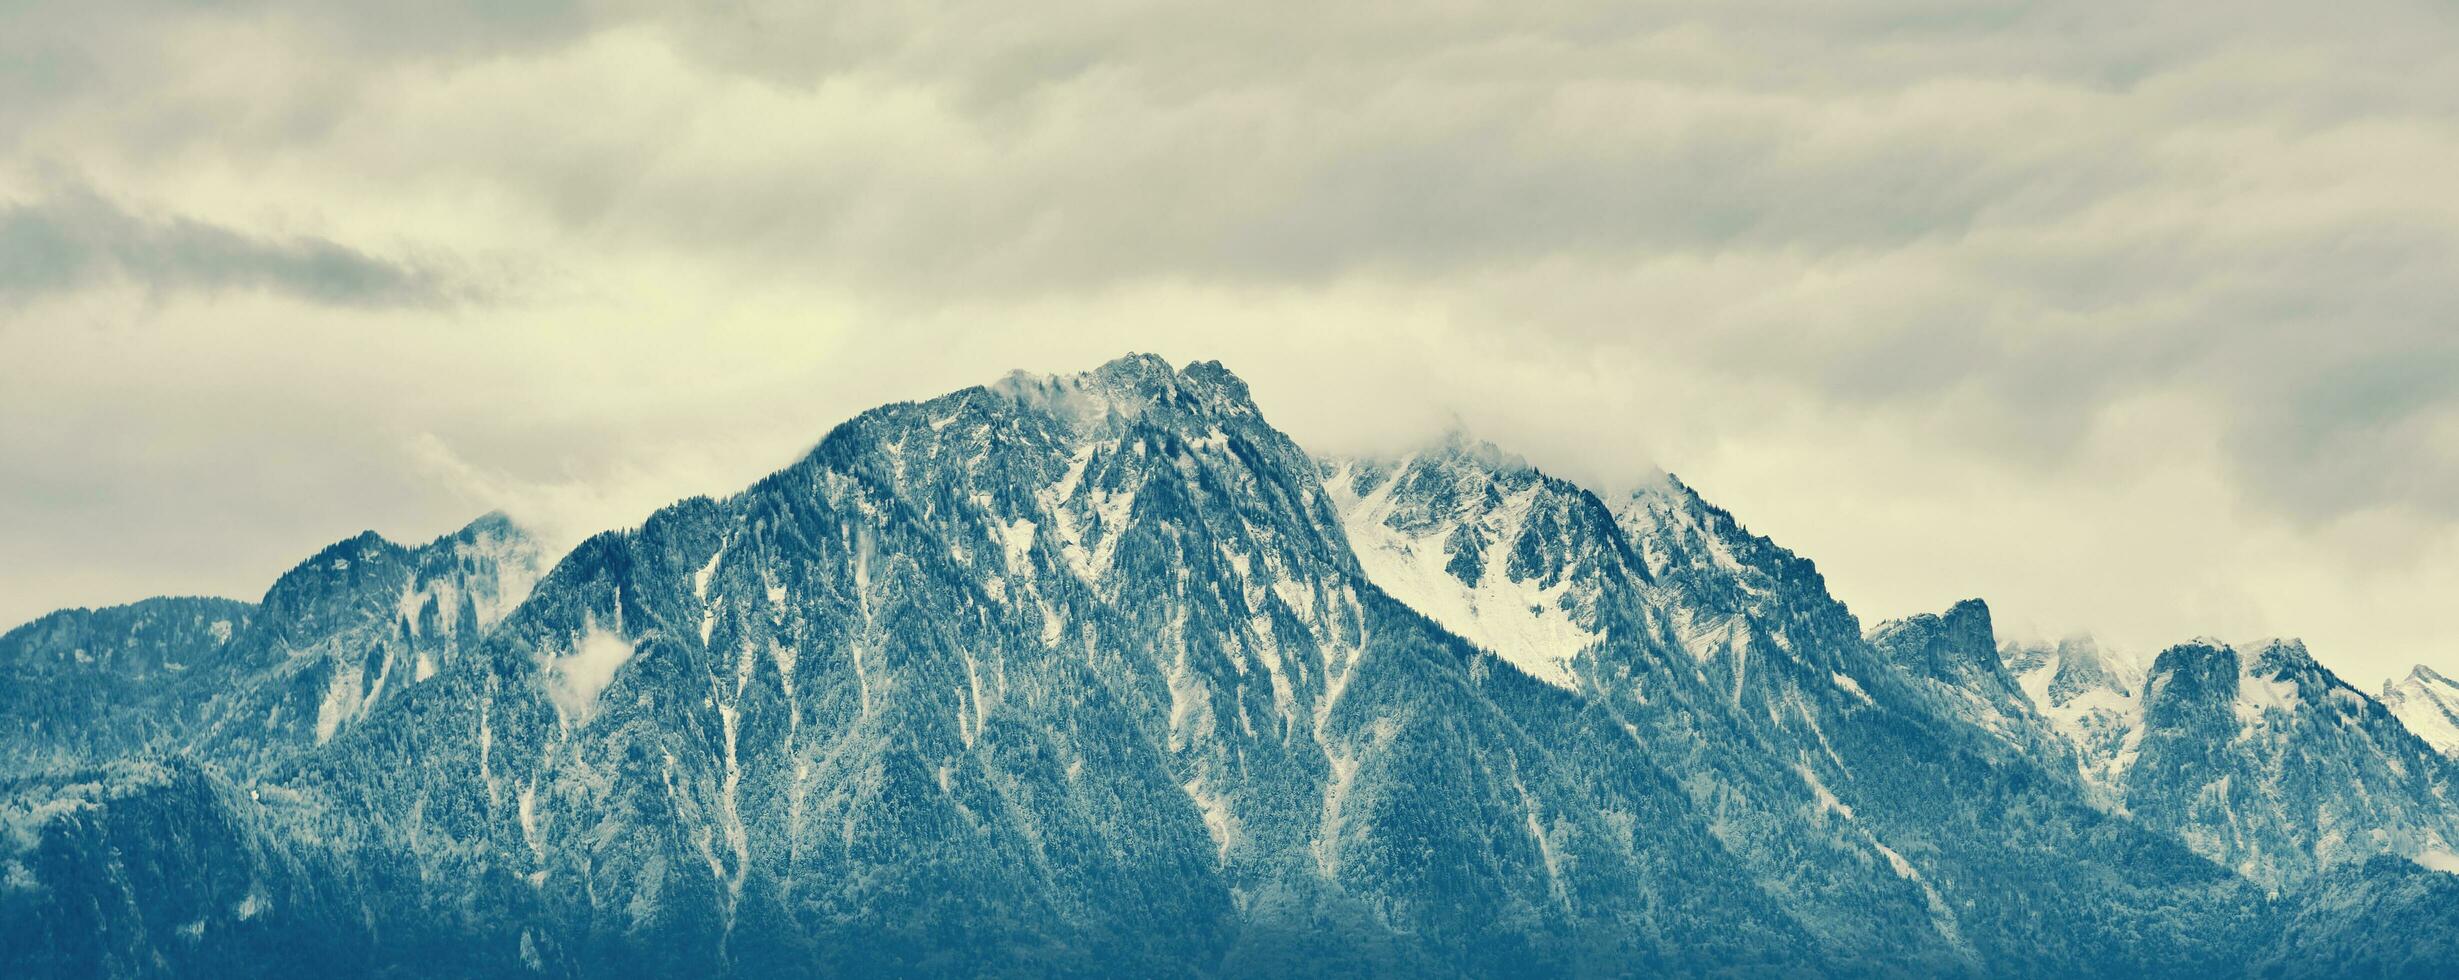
269 359 1802 973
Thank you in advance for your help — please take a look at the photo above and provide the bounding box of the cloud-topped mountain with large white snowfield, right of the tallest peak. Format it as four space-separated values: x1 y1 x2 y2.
1325 437 2235 973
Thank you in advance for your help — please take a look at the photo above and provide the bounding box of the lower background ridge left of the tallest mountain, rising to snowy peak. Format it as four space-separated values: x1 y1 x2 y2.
0 516 539 771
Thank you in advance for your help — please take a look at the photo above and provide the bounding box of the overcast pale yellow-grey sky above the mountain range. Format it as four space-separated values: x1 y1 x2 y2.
0 0 2459 688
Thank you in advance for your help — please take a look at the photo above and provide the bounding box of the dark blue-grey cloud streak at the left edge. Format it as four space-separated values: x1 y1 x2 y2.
0 192 455 307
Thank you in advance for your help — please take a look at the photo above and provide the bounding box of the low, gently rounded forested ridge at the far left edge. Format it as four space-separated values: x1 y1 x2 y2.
0 599 256 771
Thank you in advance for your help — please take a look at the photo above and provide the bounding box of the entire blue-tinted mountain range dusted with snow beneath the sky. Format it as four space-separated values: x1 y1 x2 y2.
0 356 2459 978
